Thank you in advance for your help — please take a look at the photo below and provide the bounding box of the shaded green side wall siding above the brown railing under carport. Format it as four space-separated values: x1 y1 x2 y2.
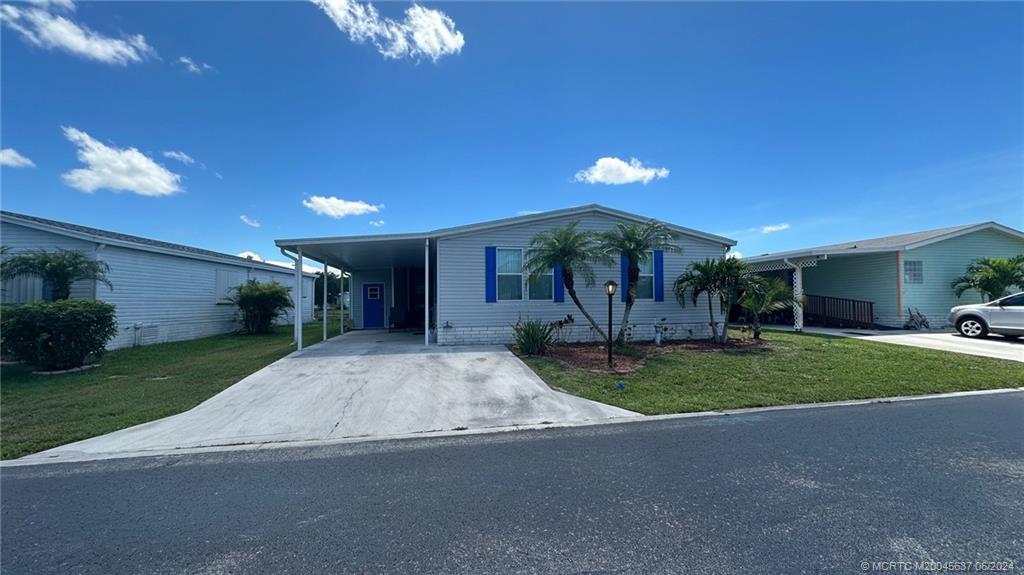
804 252 903 327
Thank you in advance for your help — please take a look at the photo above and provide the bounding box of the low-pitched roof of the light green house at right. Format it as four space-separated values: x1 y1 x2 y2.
743 222 1024 264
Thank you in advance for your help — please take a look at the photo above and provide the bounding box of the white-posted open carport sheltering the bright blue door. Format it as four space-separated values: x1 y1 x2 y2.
275 233 437 350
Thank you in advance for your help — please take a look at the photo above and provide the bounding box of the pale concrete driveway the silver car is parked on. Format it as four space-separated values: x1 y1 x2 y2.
765 325 1024 362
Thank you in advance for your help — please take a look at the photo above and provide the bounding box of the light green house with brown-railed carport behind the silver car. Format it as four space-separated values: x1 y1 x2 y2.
743 222 1024 328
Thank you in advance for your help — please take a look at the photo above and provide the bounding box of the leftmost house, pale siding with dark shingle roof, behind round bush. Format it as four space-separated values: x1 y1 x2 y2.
0 212 313 349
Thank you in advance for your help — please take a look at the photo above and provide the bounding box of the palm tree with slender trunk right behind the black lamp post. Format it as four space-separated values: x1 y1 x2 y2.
598 220 682 344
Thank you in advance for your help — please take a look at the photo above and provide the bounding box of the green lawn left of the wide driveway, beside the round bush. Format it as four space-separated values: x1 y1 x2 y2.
0 312 339 459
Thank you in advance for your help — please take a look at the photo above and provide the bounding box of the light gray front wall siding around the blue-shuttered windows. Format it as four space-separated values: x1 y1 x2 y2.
436 214 725 343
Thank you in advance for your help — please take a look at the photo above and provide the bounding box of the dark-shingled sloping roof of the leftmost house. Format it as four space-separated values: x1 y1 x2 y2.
0 211 313 276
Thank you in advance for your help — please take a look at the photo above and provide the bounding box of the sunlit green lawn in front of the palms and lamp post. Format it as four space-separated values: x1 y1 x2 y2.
524 331 1024 414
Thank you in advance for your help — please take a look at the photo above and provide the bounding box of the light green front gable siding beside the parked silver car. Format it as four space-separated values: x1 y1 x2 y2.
902 229 1024 327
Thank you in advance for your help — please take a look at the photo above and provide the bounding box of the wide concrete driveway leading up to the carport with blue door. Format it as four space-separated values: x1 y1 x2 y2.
23 331 637 460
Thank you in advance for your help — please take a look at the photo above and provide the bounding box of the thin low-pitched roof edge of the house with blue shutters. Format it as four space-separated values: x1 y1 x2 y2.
274 204 736 248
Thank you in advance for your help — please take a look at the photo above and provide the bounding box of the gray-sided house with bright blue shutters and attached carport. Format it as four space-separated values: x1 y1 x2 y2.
276 205 735 345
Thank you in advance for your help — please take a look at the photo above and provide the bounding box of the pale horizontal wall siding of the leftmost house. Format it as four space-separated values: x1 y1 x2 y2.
3 219 313 349
